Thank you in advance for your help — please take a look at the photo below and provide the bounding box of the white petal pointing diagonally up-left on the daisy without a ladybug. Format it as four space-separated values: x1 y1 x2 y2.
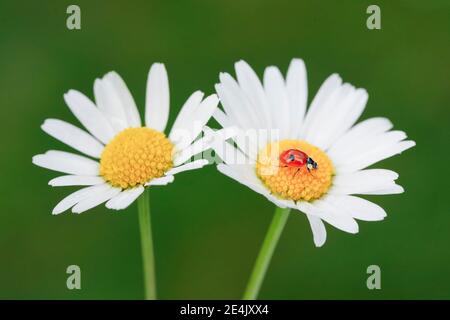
64 90 115 144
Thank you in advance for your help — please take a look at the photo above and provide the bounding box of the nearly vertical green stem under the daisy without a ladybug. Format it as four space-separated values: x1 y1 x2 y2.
138 191 156 300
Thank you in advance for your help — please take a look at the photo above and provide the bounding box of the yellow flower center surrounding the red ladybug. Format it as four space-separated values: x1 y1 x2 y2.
256 140 334 201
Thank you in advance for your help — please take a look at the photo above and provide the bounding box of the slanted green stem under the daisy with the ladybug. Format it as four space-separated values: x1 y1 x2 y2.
243 207 290 300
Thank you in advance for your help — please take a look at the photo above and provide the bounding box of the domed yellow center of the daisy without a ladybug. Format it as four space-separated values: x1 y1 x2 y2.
100 128 173 189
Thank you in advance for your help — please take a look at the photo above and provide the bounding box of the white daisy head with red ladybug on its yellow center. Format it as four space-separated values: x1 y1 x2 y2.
213 59 415 246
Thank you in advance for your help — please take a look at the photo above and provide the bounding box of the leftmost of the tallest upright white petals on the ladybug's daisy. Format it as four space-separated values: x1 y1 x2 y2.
234 60 272 129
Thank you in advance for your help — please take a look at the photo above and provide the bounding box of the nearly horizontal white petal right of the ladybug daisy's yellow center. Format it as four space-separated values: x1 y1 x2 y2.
329 169 398 194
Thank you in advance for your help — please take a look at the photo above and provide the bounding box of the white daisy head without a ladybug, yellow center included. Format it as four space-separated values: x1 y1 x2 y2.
33 63 218 214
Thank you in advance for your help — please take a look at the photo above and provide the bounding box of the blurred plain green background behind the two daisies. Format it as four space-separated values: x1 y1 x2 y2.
0 0 450 299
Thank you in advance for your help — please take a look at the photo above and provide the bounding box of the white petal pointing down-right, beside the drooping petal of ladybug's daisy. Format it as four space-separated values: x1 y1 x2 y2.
297 198 359 233
